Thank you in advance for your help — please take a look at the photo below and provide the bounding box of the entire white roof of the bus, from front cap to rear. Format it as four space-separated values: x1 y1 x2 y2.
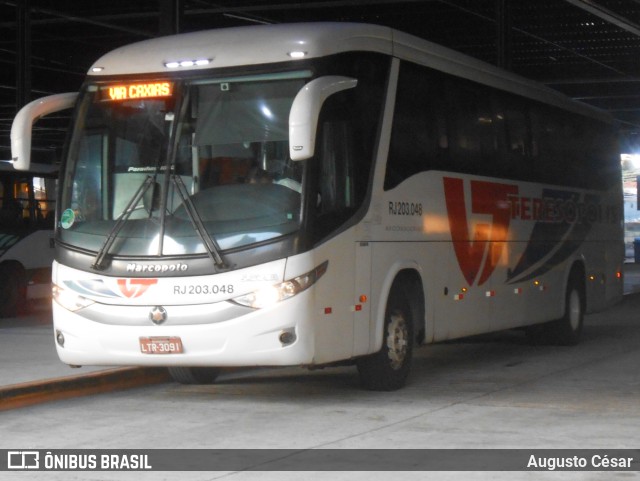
89 22 612 122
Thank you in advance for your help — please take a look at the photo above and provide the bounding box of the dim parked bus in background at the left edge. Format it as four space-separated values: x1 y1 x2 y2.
0 163 57 317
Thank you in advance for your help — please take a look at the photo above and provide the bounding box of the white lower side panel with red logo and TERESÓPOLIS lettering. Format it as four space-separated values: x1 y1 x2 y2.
372 171 622 341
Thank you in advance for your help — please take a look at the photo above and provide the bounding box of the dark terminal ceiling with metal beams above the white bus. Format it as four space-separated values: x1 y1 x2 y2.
0 0 640 160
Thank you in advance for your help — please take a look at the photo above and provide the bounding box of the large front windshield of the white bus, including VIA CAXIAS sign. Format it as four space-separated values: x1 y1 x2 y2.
58 72 308 256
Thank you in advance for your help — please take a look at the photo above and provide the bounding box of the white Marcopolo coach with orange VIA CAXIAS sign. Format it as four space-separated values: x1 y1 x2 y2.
13 23 624 390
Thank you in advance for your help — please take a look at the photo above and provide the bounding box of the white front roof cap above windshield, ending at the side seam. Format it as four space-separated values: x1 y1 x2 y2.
89 23 392 75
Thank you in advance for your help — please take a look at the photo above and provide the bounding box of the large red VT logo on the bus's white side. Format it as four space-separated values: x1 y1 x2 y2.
444 177 518 286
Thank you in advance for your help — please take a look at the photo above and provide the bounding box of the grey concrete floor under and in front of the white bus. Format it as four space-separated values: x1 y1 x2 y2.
0 265 640 481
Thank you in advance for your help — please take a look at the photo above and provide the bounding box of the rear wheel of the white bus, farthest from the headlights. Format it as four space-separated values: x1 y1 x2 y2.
527 271 586 346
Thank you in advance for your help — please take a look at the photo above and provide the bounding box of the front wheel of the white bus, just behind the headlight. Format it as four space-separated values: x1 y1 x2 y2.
356 288 414 391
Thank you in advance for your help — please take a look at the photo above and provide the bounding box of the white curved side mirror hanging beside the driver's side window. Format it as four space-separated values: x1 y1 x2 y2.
289 75 358 160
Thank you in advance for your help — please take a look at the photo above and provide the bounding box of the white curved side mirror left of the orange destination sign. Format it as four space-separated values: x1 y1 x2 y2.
11 92 78 170
